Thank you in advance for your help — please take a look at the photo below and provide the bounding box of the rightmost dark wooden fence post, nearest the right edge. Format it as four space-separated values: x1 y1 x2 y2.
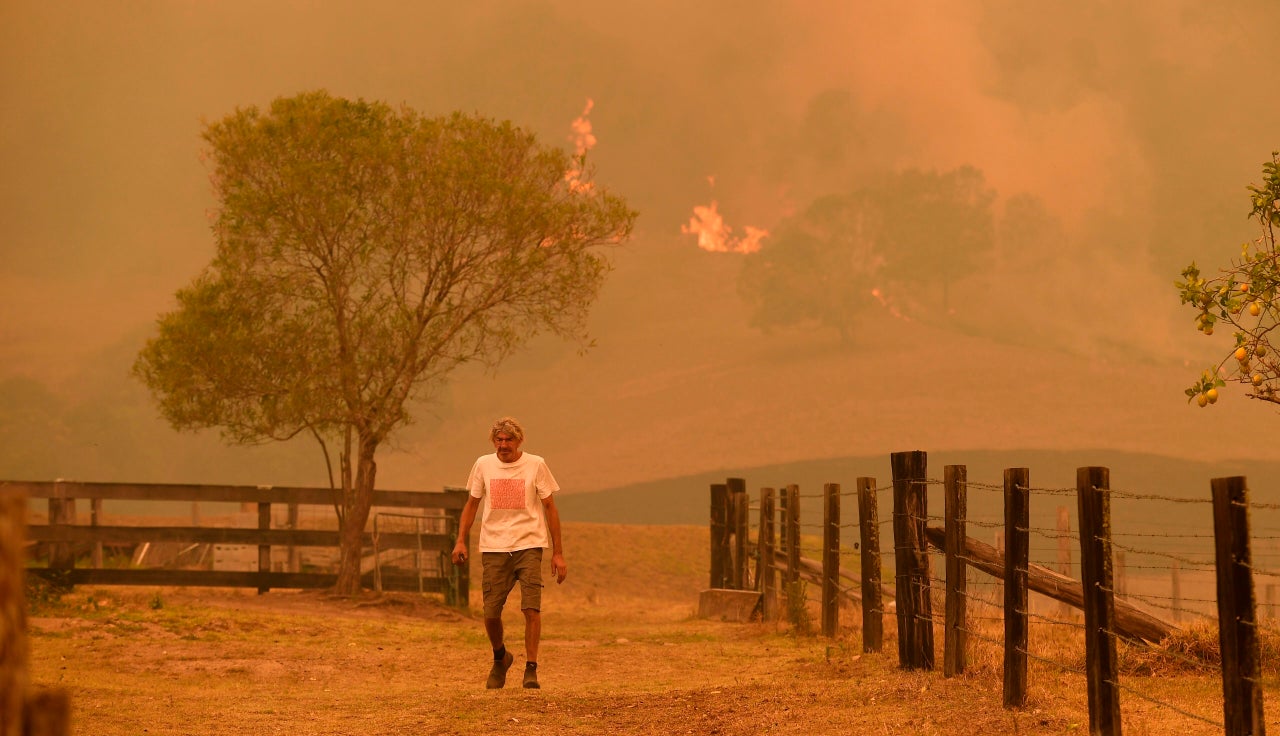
1210 476 1266 736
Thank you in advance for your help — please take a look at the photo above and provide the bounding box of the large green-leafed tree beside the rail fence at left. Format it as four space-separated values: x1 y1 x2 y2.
134 92 636 594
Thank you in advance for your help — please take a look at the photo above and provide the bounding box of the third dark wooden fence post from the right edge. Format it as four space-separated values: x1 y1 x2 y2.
1005 467 1030 708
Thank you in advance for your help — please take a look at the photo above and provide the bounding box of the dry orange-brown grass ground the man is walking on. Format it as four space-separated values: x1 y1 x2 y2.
22 524 1280 736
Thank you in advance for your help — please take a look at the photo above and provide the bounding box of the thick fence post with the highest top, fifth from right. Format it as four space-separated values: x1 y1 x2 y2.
891 451 933 669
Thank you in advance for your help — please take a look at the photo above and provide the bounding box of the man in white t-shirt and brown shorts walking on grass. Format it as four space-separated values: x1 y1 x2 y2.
453 416 567 689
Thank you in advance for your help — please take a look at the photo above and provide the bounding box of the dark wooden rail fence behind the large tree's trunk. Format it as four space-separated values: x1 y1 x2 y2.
10 481 470 607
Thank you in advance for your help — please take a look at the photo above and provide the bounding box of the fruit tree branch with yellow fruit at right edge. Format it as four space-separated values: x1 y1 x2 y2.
1175 151 1280 406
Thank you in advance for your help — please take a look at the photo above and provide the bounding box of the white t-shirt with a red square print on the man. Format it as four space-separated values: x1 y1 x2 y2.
467 452 559 552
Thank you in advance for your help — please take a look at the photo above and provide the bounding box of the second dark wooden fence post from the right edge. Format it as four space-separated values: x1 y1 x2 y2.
1075 467 1120 736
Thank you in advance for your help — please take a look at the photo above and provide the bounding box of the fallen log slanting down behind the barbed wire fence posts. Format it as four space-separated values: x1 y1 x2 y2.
924 526 1178 644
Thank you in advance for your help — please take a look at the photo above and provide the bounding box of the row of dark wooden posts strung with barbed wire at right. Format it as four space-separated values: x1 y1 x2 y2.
710 452 1280 736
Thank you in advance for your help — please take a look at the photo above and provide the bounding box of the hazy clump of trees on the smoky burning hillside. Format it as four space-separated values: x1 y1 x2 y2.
740 166 995 340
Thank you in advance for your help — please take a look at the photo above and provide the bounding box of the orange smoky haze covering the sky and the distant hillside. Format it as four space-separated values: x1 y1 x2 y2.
0 0 1280 490
